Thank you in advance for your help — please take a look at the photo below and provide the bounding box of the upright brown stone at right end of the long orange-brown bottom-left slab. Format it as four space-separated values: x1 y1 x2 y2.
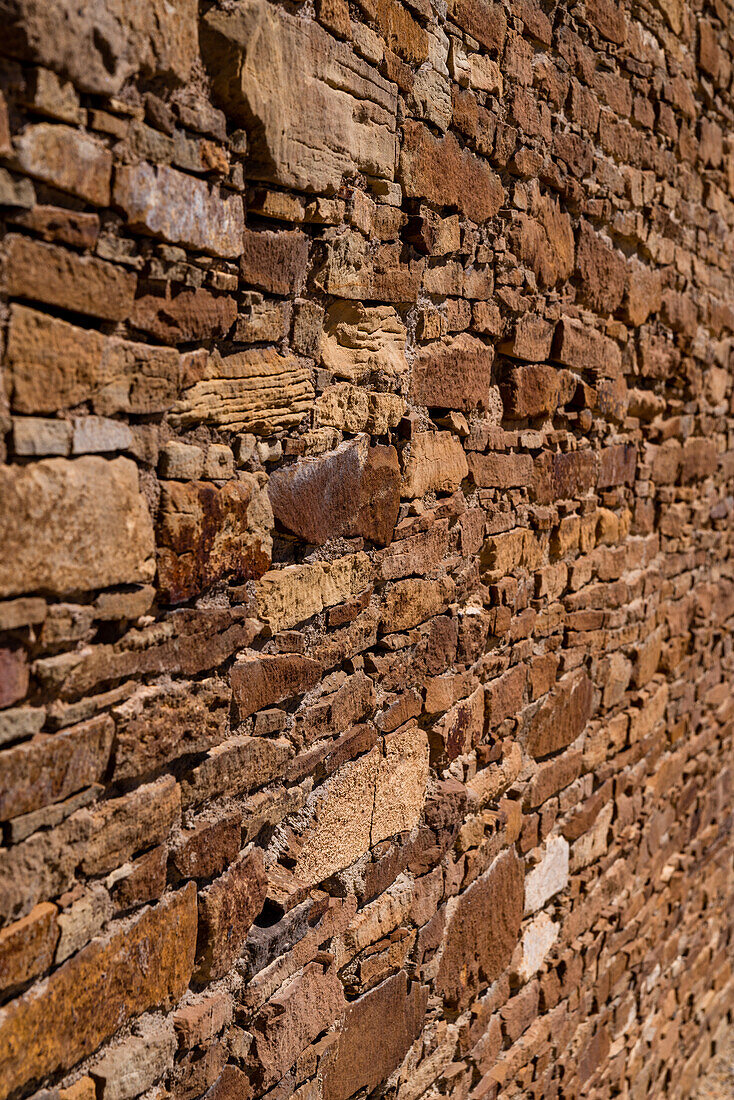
196 848 267 981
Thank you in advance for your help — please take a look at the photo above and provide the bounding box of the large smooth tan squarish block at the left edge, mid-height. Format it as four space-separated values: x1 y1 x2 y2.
0 457 153 596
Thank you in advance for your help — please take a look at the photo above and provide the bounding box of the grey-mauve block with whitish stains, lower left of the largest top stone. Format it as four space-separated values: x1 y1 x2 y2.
113 163 244 256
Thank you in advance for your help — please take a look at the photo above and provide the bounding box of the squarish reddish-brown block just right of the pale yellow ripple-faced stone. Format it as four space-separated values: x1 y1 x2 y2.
410 332 494 411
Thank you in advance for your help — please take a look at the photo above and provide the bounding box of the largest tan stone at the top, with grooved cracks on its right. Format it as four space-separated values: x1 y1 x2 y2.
201 0 397 191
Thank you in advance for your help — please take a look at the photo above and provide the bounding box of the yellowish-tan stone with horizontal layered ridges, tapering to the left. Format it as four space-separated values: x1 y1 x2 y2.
173 348 314 436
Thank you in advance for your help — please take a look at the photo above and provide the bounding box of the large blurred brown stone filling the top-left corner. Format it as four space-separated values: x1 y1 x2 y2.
2 0 197 96
